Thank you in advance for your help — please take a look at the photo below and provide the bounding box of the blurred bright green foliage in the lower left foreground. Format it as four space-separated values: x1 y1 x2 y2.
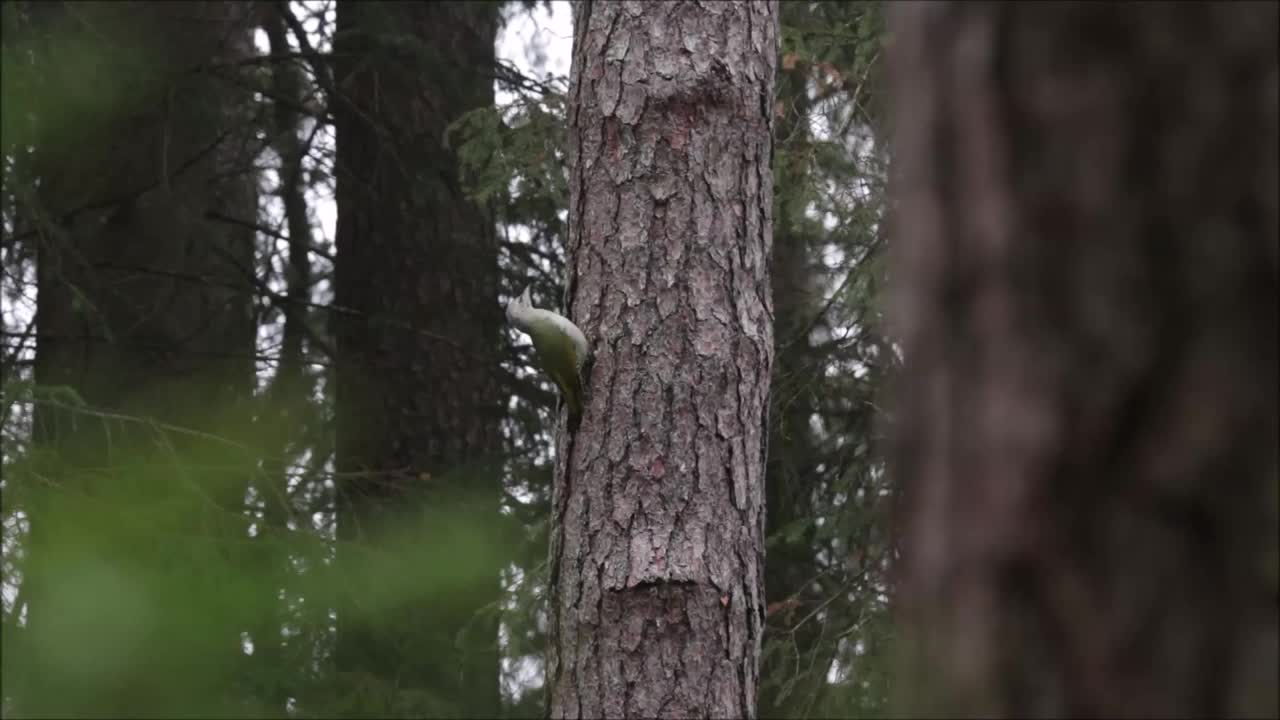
4 384 506 716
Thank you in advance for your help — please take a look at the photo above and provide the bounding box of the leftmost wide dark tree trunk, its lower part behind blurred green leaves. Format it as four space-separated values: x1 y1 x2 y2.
18 3 256 716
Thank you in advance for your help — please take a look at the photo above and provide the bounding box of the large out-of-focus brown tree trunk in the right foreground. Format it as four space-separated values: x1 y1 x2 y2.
892 3 1280 717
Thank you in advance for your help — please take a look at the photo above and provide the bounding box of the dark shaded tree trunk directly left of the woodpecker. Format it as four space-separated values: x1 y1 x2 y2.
334 3 503 717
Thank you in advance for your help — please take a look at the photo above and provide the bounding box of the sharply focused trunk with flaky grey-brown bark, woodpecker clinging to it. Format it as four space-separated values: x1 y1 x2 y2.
548 1 778 717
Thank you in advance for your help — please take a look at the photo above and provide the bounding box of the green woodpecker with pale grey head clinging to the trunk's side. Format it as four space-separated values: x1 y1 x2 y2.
507 287 591 425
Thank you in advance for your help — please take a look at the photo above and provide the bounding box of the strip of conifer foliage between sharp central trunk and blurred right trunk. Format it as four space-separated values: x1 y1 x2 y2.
760 3 892 717
